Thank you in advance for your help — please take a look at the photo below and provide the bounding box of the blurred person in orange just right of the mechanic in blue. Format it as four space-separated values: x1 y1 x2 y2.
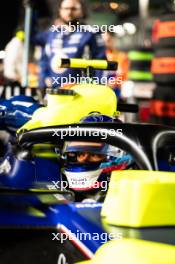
102 32 128 97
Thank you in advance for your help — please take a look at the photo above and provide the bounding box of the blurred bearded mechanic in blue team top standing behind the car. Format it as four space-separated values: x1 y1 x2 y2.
35 0 106 88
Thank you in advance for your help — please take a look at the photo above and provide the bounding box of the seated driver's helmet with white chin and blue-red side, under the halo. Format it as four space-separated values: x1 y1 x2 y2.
59 115 132 192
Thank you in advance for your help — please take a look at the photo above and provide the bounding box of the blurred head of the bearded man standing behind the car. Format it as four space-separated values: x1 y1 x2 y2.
58 0 86 24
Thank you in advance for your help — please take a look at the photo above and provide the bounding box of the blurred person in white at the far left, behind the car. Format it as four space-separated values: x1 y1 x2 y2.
4 30 24 85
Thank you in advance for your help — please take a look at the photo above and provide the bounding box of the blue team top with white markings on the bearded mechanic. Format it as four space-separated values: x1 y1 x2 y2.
35 28 106 88
